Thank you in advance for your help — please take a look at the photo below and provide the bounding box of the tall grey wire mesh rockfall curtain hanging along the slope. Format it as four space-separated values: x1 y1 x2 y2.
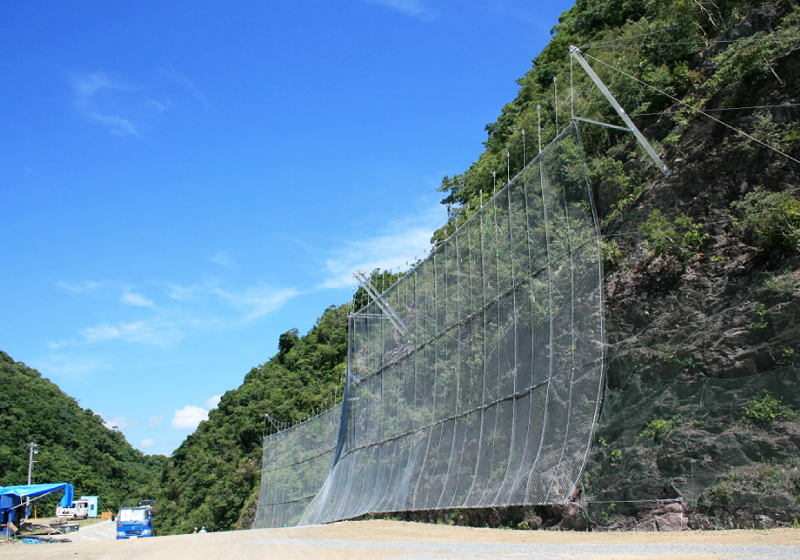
255 120 604 527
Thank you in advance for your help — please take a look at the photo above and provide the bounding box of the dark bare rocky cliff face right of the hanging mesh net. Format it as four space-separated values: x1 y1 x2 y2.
583 2 800 529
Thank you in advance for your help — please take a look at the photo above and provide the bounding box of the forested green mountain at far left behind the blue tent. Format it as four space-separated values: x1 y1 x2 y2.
0 351 166 516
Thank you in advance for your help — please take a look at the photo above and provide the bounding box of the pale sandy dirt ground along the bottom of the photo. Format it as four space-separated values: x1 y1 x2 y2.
0 520 800 560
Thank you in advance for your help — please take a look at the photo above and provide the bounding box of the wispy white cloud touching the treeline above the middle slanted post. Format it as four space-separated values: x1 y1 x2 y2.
319 204 446 289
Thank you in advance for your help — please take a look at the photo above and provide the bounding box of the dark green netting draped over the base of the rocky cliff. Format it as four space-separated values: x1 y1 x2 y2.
583 366 800 520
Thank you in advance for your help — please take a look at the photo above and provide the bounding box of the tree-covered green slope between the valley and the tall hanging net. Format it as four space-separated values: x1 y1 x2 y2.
159 305 350 533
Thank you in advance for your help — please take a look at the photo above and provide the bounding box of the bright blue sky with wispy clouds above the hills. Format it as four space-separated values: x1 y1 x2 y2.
0 0 571 454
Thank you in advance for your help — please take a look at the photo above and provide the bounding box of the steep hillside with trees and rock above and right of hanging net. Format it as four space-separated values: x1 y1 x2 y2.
434 0 800 528
